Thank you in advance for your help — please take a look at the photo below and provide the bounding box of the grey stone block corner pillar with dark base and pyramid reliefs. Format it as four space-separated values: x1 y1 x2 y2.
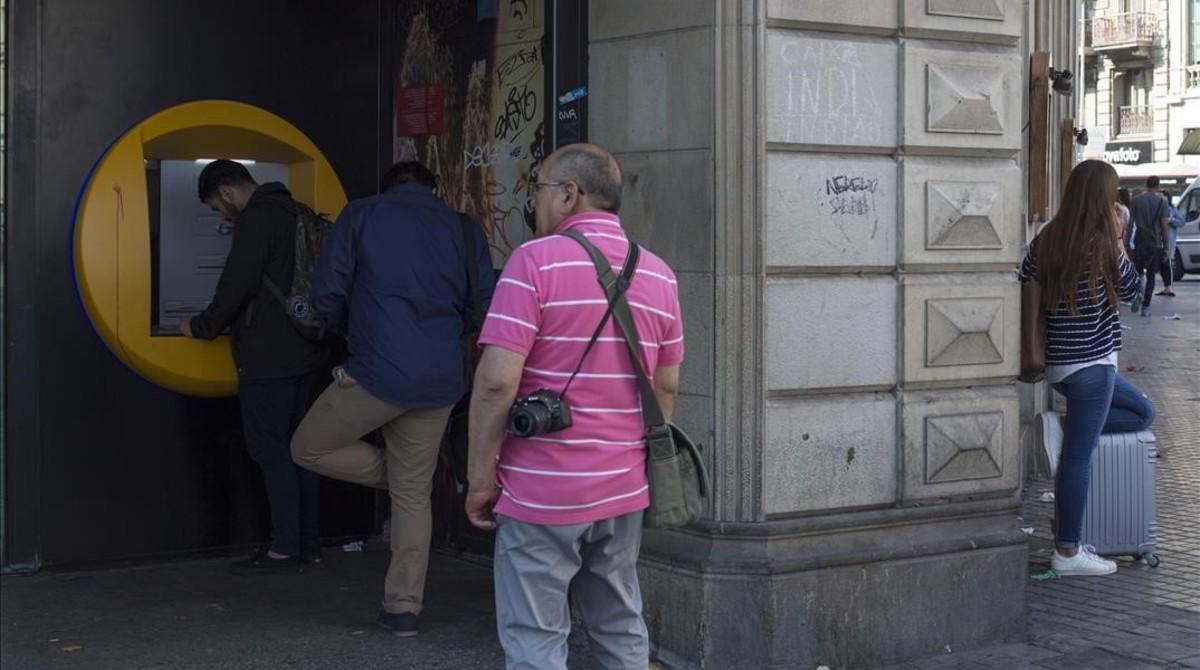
589 0 1027 668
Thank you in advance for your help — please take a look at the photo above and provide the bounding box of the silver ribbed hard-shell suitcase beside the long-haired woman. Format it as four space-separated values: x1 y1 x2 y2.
1080 430 1158 568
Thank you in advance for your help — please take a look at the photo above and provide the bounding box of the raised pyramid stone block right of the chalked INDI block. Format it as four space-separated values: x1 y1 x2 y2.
902 42 1025 156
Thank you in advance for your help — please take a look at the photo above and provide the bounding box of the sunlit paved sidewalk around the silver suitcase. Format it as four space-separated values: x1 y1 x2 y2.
902 276 1200 670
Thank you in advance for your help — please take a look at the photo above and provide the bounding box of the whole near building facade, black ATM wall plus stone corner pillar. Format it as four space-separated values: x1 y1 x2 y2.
2 0 1089 668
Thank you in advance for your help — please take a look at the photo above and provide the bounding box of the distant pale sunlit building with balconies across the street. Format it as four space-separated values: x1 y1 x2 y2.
1079 0 1200 196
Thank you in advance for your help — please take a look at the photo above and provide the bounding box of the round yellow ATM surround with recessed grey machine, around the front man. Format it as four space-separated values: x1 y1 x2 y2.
73 100 346 397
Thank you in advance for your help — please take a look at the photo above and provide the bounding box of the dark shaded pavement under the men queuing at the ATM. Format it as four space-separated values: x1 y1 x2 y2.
0 540 600 670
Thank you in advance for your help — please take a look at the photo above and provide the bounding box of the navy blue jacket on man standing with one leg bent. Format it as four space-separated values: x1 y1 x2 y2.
312 183 496 408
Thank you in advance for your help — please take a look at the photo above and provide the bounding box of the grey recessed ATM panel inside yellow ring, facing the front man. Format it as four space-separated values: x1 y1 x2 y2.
146 161 288 336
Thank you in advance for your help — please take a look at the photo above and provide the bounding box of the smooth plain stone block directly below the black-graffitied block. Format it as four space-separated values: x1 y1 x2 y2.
763 276 896 390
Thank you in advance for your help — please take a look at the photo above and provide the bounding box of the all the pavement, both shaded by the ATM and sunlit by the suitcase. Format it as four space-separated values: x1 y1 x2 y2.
0 284 1200 670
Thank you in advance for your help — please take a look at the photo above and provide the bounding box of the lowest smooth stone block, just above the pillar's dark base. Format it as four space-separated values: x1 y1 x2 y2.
763 394 898 515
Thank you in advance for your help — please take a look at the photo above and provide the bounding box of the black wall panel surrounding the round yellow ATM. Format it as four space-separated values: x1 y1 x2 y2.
4 0 391 569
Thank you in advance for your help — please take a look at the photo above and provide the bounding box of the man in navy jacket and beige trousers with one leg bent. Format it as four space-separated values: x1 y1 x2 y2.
292 162 496 636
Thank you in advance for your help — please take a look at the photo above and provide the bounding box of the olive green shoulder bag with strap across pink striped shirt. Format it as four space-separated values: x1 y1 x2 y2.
564 231 709 528
